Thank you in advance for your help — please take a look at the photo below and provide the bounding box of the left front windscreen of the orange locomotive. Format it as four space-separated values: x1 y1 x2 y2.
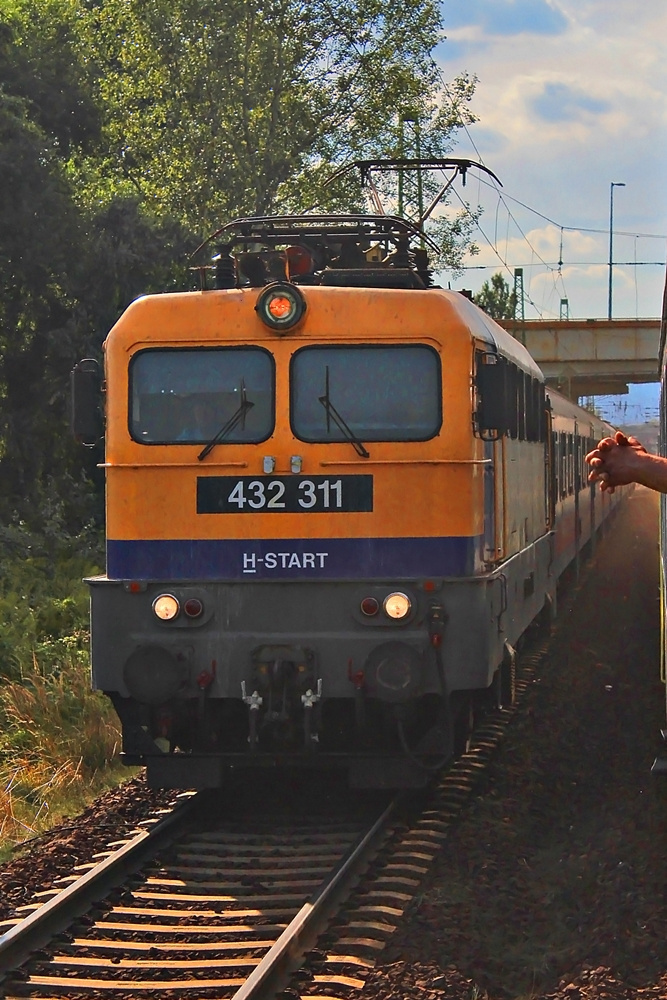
129 347 275 444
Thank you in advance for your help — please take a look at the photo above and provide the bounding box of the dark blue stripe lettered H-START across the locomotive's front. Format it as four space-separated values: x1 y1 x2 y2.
107 537 479 580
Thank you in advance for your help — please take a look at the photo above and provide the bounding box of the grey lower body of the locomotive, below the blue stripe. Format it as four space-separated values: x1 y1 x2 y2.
89 536 555 787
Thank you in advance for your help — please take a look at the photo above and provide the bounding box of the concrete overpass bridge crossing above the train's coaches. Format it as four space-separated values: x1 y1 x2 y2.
500 319 660 400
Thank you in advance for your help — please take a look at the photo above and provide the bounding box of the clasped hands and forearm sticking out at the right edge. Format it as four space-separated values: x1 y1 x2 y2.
586 431 667 493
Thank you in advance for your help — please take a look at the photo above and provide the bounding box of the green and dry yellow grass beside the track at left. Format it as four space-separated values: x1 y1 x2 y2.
0 544 127 845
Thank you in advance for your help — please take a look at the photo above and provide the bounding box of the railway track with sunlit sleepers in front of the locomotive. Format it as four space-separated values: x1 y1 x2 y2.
0 628 546 1000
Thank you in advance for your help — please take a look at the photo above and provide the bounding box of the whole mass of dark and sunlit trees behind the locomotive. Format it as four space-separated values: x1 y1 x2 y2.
0 0 475 529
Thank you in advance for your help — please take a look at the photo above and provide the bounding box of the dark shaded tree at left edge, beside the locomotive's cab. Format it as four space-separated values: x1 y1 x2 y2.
0 0 194 526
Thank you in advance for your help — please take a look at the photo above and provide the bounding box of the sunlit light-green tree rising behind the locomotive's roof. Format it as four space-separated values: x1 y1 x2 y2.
70 0 474 234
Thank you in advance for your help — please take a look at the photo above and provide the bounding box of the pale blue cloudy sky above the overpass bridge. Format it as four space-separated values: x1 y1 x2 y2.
436 0 667 416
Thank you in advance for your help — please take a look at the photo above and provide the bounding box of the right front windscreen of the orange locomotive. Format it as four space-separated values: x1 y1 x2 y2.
290 345 442 442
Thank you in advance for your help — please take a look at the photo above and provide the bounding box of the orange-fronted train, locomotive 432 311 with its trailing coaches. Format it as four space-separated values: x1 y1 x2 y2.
72 166 622 788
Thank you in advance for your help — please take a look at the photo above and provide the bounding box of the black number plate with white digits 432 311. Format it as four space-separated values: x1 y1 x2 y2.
197 476 373 514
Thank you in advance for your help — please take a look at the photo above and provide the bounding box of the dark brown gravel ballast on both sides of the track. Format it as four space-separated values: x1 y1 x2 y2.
0 489 667 1000
